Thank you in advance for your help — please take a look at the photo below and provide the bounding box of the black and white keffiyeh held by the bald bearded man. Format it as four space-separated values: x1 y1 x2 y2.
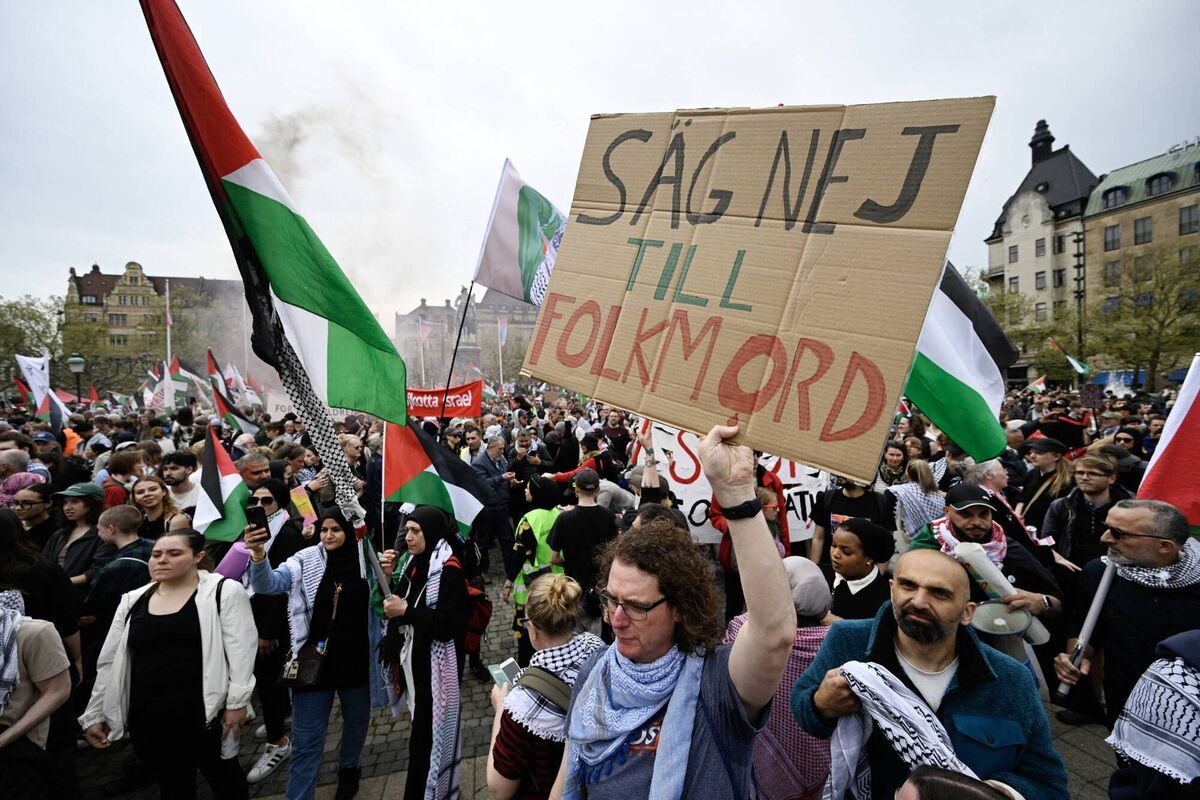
821 661 977 800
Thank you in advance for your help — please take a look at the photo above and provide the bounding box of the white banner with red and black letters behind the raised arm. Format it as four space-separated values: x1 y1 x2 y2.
637 422 829 545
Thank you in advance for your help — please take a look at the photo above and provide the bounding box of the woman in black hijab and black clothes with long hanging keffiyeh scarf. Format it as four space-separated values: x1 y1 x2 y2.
379 505 469 800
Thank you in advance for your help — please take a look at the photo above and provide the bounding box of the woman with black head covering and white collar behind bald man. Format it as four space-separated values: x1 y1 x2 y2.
827 517 895 621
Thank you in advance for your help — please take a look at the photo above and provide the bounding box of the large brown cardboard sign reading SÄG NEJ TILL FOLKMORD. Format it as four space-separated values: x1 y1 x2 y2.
523 97 995 481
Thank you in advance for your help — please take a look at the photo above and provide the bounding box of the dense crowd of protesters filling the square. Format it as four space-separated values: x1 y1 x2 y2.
0 376 1200 800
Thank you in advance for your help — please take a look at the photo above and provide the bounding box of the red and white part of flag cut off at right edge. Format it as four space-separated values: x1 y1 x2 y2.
1138 354 1200 537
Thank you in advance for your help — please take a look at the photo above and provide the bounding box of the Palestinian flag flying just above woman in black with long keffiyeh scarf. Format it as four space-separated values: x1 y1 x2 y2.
383 422 485 539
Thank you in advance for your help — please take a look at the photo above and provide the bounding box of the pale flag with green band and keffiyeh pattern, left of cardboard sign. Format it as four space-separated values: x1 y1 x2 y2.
475 158 566 307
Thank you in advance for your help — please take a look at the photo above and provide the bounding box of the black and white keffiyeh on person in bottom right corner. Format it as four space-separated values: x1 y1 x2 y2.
1108 658 1200 783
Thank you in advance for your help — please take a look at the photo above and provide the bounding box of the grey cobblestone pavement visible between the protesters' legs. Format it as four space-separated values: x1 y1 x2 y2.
77 553 1115 800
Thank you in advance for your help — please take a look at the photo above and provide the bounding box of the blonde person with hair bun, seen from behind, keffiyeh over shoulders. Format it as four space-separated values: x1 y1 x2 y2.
487 573 604 800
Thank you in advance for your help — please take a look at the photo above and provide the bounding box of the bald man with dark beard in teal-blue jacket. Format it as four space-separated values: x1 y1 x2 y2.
792 549 1069 800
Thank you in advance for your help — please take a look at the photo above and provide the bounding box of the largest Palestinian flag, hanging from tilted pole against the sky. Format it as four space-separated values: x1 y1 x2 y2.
142 0 408 425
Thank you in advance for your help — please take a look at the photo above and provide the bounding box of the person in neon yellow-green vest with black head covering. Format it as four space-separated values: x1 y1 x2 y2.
500 475 563 667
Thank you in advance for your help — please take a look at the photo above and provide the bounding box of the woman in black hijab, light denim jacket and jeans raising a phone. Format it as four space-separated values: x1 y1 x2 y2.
245 509 379 800
